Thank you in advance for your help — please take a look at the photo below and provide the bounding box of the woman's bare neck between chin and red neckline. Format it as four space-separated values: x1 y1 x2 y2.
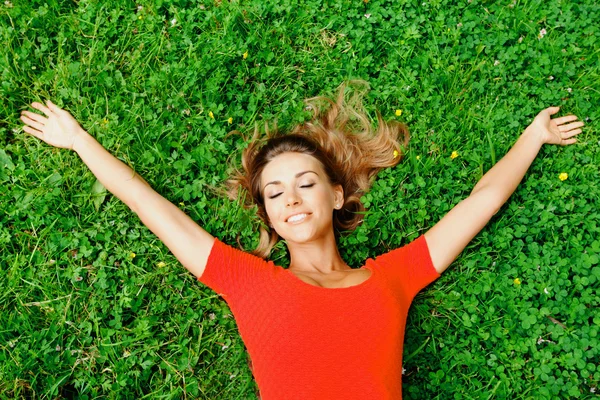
288 231 351 275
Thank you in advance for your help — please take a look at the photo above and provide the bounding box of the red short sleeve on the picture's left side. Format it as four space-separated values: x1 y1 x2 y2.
198 238 275 302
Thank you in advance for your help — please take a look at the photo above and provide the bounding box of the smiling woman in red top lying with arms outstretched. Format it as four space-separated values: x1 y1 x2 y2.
21 88 583 399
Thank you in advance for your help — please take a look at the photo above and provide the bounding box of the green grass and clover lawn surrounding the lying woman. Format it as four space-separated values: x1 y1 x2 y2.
0 0 600 399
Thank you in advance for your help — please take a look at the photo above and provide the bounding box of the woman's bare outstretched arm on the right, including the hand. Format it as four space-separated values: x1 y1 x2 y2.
425 107 583 274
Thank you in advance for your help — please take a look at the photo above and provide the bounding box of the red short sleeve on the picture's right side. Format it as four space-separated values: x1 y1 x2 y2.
375 235 440 300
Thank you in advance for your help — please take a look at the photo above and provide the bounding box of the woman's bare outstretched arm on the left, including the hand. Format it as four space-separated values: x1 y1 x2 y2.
21 101 214 278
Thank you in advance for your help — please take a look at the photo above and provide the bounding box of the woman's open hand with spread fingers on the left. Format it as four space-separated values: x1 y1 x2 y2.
21 100 85 150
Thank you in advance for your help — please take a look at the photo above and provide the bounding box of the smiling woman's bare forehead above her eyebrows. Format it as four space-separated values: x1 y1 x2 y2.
261 153 325 187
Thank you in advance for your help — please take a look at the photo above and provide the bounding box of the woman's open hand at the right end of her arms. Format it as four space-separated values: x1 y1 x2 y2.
526 107 584 146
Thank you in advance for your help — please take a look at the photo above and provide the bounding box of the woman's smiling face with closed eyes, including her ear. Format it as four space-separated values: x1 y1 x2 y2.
260 153 343 243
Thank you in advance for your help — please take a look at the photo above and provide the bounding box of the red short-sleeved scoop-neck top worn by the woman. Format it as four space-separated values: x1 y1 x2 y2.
198 236 439 400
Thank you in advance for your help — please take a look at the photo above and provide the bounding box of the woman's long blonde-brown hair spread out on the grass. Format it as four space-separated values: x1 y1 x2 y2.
227 81 409 258
